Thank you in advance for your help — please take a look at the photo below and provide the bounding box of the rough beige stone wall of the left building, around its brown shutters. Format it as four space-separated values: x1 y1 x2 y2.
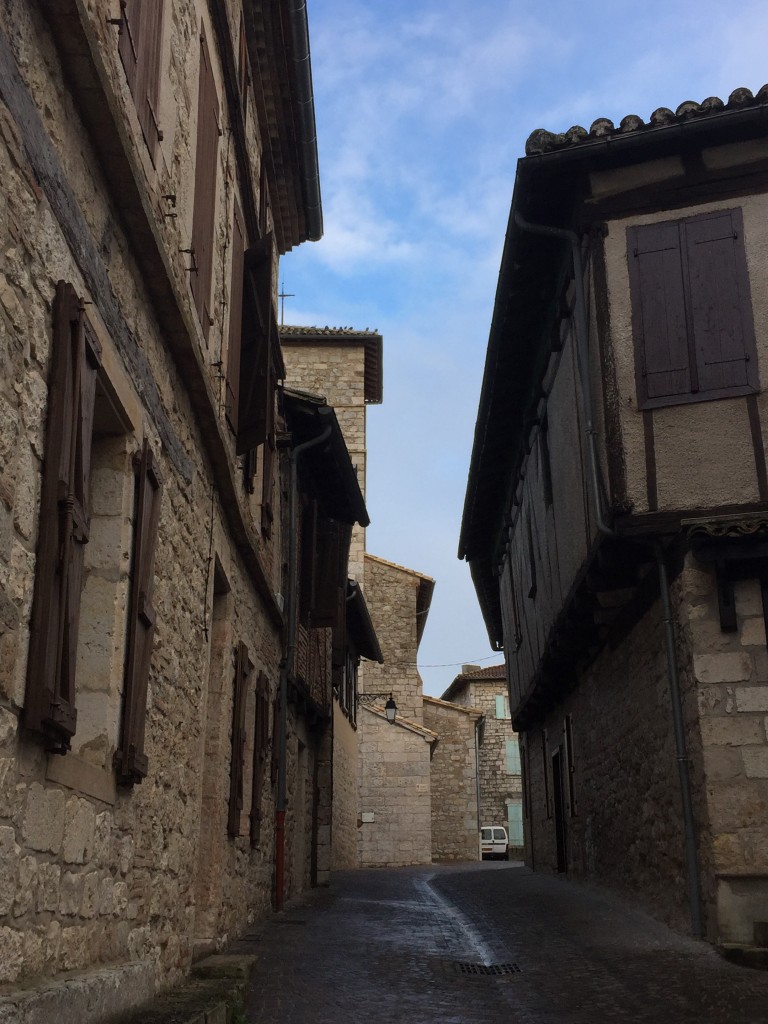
0 0 313 999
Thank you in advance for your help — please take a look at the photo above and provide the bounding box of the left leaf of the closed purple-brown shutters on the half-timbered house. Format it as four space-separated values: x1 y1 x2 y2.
629 221 691 406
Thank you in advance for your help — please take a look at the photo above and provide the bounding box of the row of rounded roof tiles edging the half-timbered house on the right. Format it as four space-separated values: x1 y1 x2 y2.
525 84 768 157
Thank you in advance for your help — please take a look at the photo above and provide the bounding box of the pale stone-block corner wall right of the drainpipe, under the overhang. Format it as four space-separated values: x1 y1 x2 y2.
680 556 768 944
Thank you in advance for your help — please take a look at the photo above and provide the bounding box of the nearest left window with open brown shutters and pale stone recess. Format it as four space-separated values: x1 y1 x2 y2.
24 282 162 784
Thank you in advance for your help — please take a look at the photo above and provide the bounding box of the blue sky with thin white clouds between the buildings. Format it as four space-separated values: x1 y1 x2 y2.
281 0 768 695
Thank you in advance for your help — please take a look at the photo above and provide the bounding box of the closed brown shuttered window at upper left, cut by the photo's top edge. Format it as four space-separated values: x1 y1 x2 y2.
118 0 163 164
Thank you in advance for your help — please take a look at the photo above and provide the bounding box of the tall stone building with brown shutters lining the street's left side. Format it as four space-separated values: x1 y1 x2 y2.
0 0 367 1021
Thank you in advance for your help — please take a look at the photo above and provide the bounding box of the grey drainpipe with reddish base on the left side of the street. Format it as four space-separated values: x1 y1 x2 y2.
274 410 331 910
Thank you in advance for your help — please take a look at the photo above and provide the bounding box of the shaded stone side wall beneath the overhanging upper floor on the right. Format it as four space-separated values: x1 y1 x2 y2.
521 602 701 930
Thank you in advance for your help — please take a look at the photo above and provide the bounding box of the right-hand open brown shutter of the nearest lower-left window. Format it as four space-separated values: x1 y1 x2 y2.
115 440 163 785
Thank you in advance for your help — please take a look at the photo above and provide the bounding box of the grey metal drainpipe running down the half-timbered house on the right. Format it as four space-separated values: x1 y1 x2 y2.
514 211 703 938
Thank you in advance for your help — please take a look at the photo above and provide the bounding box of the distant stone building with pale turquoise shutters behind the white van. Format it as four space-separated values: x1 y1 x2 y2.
442 665 523 856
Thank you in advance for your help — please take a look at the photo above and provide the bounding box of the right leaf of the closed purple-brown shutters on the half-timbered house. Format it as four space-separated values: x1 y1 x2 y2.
681 210 758 392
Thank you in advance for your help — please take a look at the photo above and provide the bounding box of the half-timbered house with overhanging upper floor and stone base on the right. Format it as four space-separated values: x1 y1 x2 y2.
460 86 768 945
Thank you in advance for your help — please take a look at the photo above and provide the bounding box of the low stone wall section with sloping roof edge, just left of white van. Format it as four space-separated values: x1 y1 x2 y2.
424 696 481 860
